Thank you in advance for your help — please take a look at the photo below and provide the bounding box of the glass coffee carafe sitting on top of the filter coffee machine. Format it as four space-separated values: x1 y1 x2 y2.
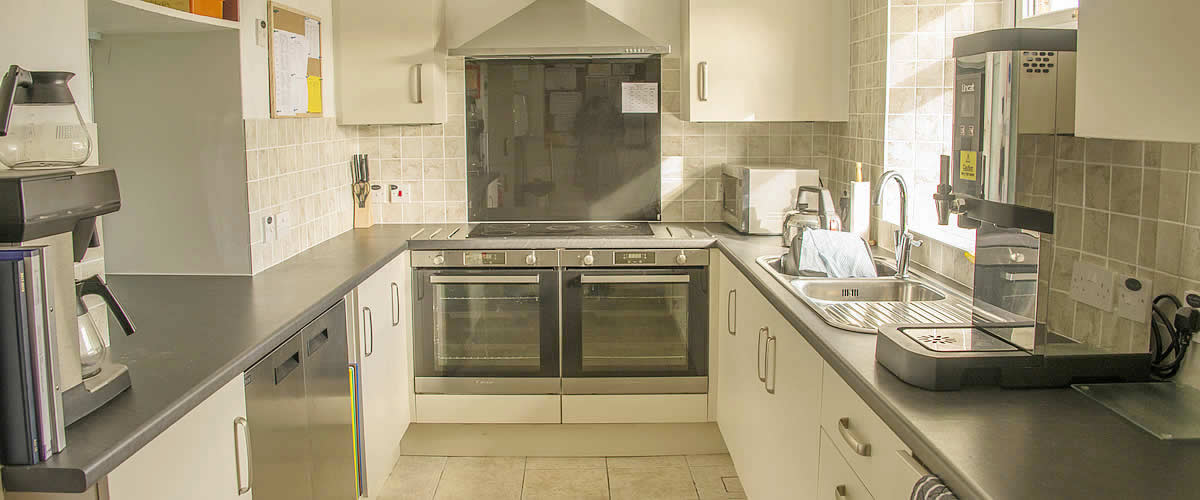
0 65 91 169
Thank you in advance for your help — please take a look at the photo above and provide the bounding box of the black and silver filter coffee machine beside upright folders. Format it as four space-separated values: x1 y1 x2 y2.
0 167 133 463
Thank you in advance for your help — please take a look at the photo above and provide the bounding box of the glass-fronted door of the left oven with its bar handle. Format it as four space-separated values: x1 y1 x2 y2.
413 269 560 394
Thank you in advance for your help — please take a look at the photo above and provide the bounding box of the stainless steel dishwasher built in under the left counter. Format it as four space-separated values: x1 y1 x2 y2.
246 301 358 500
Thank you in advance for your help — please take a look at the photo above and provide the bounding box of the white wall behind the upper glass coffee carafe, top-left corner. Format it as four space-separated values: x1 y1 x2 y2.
0 0 92 121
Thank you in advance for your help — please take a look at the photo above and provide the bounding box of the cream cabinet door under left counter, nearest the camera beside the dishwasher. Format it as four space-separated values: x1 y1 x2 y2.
108 374 253 500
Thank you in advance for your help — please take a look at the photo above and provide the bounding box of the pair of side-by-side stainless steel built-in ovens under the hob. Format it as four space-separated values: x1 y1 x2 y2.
413 249 708 394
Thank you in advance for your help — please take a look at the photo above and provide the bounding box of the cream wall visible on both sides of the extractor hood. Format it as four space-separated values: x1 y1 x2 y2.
446 0 679 52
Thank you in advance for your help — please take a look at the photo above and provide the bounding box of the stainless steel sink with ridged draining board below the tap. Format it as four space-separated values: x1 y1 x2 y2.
757 255 972 333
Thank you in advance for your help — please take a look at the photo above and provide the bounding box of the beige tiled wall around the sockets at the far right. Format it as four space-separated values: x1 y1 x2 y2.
1038 137 1200 351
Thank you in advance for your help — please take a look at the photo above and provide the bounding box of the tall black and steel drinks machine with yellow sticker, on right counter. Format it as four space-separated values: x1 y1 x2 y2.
875 29 1151 390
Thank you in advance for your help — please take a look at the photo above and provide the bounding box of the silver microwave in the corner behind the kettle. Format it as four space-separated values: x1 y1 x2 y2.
721 164 833 234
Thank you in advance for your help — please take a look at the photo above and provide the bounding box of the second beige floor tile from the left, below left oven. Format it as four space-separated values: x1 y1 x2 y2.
434 457 524 500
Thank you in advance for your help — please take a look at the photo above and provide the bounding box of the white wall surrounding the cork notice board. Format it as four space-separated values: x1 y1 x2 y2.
241 0 338 119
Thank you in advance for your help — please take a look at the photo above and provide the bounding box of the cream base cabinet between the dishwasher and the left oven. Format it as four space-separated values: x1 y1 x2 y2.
355 252 413 498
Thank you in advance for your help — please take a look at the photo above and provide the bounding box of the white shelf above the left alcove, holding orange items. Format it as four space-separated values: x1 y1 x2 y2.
88 0 240 35
